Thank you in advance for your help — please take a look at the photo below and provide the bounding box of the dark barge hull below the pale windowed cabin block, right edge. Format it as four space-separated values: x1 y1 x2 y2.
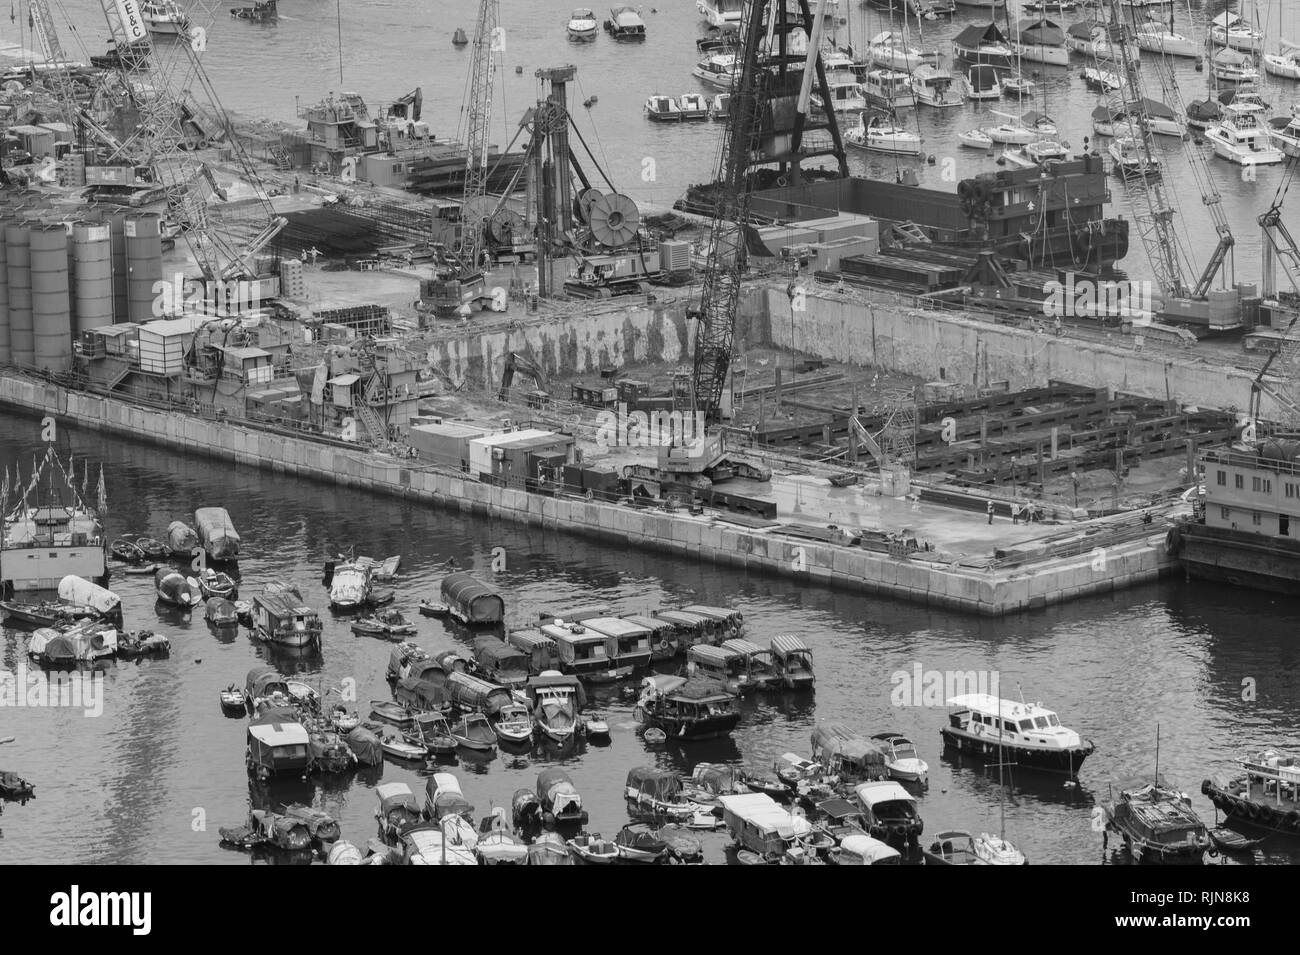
1171 524 1300 596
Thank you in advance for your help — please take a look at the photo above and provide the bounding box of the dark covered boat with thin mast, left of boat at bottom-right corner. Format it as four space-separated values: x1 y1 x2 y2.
1101 773 1212 865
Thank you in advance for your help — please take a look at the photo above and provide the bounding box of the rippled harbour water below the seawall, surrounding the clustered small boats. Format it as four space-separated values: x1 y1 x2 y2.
0 413 1300 864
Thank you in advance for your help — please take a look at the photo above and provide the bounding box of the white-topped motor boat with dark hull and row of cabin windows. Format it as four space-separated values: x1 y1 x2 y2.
940 694 1095 777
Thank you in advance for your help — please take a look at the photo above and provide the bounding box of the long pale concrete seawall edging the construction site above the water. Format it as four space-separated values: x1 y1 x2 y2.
0 376 1175 616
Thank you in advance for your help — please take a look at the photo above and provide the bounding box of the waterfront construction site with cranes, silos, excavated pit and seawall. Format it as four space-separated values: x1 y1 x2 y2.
0 0 1300 613
